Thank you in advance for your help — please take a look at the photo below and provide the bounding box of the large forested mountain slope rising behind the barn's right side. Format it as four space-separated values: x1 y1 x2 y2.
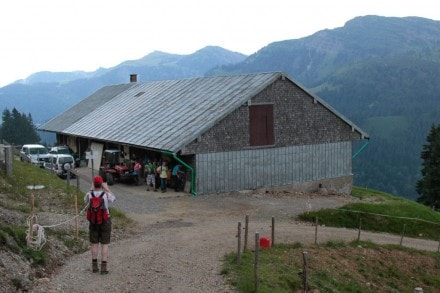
209 16 440 198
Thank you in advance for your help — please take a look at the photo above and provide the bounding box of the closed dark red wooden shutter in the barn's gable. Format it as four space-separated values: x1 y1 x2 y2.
249 105 274 146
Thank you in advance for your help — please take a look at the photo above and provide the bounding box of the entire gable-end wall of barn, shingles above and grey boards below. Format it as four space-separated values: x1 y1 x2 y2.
183 79 361 193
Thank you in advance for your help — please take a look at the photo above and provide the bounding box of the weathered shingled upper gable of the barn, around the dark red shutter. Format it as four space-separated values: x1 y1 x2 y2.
182 79 361 154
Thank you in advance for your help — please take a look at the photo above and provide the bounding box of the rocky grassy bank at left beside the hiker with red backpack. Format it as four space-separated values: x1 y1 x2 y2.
0 160 130 292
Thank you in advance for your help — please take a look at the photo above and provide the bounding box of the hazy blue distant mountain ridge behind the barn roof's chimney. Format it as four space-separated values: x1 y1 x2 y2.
0 46 246 124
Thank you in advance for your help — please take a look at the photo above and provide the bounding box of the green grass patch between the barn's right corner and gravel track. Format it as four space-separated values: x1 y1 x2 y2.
299 188 440 241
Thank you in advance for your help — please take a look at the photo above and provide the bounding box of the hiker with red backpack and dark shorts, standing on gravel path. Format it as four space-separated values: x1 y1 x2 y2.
84 176 116 274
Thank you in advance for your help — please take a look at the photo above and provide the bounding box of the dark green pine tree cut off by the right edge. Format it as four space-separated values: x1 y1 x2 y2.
416 125 440 209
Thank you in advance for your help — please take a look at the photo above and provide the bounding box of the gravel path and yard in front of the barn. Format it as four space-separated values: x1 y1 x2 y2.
30 168 438 293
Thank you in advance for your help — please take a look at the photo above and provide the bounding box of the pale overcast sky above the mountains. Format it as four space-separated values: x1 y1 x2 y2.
0 0 440 87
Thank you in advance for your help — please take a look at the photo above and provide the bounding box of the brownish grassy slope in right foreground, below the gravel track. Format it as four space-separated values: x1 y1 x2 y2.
222 241 440 293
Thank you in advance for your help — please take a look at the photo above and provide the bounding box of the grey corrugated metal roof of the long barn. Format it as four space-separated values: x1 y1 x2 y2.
39 72 368 152
